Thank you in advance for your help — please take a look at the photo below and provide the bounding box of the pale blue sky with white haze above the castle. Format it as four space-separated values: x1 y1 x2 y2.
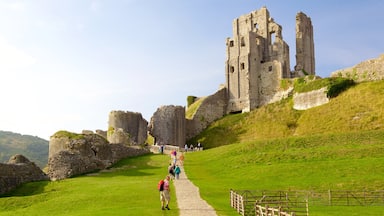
0 0 384 140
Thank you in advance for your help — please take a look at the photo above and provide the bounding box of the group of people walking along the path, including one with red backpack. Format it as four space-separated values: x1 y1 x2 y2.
159 150 184 210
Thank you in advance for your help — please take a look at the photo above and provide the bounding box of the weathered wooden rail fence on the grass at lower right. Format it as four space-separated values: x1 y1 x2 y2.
230 189 384 216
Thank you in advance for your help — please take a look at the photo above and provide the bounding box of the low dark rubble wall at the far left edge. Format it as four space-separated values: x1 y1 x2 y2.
0 155 49 194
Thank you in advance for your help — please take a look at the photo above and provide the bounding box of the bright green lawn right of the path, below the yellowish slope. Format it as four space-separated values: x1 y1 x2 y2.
185 131 384 215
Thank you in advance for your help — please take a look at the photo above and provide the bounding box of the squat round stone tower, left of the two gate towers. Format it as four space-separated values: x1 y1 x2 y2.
107 111 148 145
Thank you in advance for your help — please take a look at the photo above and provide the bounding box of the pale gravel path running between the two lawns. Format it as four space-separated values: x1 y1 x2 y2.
173 166 217 216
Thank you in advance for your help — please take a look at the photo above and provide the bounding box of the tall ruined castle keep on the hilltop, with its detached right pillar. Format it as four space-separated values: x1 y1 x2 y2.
225 7 314 113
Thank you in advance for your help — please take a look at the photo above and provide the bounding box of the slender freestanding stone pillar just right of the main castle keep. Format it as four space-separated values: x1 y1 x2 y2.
295 12 315 76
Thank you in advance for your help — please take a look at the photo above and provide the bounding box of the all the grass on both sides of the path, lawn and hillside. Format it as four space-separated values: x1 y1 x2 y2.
0 81 384 216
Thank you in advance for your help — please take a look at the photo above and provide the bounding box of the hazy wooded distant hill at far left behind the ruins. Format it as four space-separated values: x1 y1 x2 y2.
0 131 49 168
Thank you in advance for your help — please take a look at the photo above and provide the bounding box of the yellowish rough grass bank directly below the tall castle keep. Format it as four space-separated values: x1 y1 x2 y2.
188 81 384 148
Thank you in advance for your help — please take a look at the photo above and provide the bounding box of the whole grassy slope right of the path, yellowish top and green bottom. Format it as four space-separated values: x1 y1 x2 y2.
186 82 384 215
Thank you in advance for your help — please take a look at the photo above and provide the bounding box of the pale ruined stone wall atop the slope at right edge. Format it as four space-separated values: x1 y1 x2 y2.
331 54 384 82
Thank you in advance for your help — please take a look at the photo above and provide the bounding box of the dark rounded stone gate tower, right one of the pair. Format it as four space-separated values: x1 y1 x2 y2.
148 105 186 147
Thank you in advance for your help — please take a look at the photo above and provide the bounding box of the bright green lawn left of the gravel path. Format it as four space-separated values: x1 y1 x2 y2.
0 155 179 216
